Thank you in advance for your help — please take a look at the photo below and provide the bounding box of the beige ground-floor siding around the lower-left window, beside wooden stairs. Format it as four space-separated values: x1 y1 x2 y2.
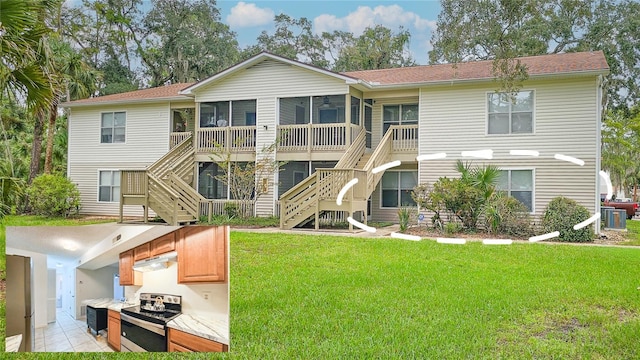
69 161 155 216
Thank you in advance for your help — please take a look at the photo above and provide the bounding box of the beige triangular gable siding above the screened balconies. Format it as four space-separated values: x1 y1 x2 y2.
196 60 349 102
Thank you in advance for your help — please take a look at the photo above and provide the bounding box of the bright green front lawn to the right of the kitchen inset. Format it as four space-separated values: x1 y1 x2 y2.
231 232 640 359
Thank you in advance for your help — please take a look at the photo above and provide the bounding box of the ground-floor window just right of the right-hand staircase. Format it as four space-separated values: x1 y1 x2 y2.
382 171 418 208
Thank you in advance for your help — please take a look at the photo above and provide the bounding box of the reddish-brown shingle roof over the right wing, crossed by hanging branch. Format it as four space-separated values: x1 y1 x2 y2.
344 51 609 85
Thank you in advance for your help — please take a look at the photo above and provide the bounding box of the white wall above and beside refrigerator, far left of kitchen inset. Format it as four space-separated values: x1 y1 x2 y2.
6 247 48 328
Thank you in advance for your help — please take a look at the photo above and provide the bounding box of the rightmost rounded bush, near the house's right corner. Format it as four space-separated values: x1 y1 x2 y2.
542 196 594 242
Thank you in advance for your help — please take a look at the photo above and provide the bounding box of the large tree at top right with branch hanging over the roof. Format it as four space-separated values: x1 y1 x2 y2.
429 0 640 107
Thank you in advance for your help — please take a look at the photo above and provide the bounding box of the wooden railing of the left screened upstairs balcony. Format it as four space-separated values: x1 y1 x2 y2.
196 126 256 153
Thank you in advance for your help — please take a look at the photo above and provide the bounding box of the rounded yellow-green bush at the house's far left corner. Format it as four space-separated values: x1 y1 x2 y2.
27 174 80 217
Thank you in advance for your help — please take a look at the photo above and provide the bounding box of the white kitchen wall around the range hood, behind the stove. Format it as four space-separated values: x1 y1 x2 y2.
125 263 229 321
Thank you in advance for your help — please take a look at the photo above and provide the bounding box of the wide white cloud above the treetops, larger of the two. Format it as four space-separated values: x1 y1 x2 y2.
313 5 436 35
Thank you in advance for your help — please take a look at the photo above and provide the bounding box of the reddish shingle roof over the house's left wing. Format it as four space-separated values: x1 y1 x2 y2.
60 83 193 107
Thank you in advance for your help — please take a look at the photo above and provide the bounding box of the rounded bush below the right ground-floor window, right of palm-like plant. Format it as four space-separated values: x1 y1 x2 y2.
483 192 532 237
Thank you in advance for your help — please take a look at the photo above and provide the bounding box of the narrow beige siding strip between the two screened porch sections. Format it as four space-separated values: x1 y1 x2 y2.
255 97 278 216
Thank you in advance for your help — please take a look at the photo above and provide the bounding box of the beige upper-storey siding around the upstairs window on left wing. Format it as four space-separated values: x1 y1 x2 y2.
69 103 171 162
